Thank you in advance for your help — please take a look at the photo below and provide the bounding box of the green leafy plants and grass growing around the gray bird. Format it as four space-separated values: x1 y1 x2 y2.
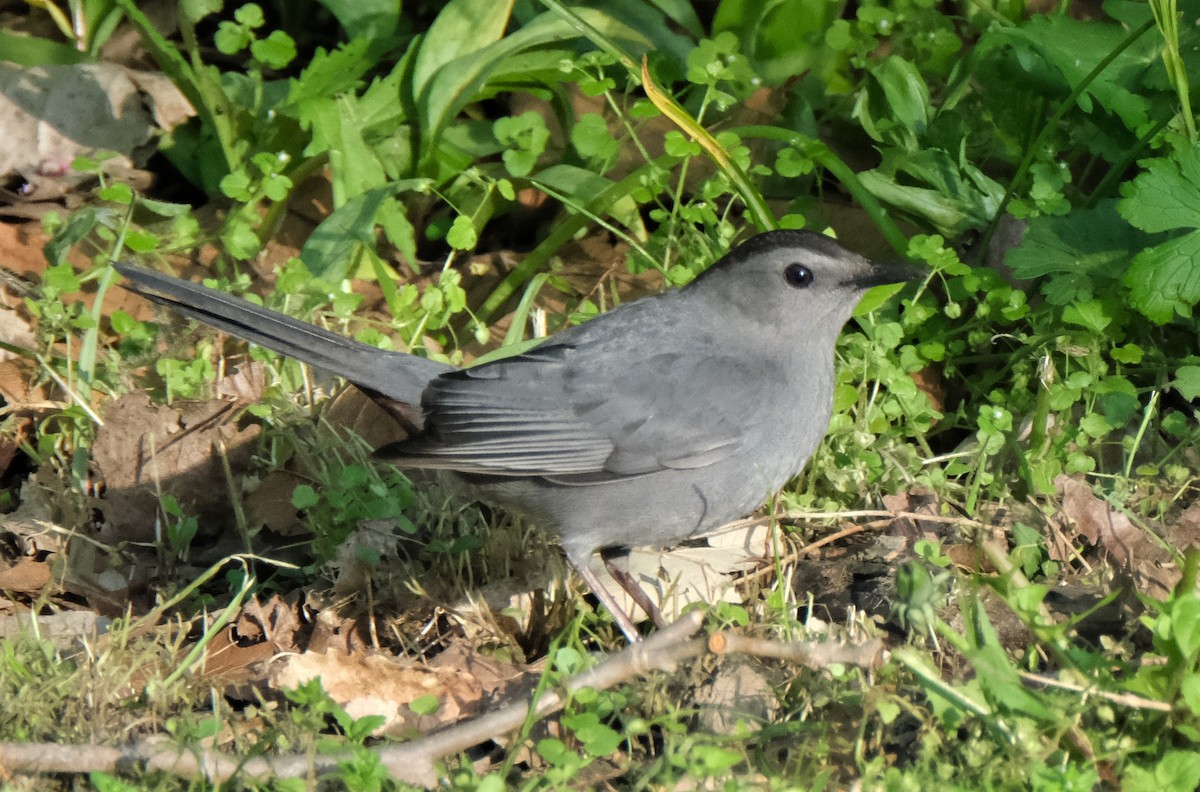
0 0 1200 792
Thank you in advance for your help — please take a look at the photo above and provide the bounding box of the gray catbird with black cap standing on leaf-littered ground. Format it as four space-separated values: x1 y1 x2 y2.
116 230 918 641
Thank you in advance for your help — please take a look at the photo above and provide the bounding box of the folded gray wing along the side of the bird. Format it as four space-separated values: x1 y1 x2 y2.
380 343 760 484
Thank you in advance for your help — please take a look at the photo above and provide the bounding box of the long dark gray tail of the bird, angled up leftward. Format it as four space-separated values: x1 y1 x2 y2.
115 262 455 406
